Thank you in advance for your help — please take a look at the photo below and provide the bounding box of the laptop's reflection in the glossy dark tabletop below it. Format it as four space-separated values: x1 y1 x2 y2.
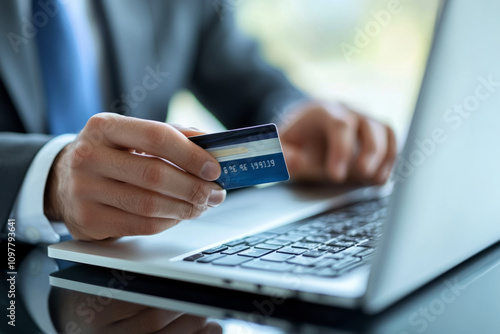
50 240 500 334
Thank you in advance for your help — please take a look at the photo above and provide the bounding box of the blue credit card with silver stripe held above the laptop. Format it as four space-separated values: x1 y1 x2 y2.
189 124 290 189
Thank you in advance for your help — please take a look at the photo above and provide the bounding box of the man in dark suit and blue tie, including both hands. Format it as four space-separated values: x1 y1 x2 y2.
0 0 396 243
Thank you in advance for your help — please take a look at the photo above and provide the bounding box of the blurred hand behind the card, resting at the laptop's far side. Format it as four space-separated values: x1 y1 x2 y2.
280 103 396 184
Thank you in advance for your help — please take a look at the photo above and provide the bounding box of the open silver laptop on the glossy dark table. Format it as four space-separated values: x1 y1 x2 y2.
49 0 500 313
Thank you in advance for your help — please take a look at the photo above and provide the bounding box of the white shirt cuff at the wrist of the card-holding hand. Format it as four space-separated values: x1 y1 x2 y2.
12 134 76 244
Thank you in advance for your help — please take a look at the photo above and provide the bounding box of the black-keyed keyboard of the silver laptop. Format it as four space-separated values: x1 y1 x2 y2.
184 198 388 277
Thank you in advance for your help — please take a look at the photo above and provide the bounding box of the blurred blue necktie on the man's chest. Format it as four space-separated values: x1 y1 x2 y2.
33 0 100 135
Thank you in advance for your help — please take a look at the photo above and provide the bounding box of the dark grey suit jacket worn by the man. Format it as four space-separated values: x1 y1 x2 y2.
0 0 302 225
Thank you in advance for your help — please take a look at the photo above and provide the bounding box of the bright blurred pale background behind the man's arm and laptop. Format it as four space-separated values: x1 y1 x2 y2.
167 0 439 139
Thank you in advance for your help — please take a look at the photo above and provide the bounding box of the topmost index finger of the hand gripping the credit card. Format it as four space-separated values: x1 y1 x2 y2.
82 113 221 181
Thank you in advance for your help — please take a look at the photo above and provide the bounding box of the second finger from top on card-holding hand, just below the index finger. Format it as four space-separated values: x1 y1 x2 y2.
83 148 226 206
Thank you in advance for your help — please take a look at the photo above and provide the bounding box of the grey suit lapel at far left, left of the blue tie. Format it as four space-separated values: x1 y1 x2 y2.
0 0 46 132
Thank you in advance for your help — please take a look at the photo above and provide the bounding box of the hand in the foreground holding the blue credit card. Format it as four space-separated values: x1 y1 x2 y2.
45 113 226 240
